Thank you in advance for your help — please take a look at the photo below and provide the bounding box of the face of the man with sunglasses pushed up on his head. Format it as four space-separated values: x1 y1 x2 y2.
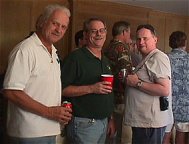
136 28 157 56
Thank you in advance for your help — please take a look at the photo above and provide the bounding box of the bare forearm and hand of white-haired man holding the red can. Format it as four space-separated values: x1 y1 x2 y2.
3 90 72 124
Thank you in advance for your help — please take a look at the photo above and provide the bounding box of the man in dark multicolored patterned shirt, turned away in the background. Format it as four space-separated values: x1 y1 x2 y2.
104 21 132 104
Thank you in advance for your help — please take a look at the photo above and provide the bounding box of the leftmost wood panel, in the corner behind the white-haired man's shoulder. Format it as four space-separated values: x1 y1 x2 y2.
0 1 32 73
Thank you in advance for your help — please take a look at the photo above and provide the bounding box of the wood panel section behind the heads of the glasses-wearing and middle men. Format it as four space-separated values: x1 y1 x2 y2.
72 0 151 49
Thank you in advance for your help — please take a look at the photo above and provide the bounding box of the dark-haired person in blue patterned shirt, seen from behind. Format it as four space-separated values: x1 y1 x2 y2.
167 31 189 144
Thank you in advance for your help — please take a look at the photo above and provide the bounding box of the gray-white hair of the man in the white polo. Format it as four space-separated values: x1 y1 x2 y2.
35 4 71 30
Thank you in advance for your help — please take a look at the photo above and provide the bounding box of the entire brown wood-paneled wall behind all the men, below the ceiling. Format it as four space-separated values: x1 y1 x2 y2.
0 0 189 73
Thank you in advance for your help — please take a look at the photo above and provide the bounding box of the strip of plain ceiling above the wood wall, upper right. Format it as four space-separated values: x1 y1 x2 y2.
103 0 189 16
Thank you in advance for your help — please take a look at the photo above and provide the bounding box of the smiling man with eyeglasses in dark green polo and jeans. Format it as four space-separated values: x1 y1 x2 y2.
62 18 115 144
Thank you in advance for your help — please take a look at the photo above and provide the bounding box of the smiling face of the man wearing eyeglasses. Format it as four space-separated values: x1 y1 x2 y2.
85 21 107 49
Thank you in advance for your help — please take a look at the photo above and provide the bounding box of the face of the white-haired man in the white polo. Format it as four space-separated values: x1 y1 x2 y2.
42 10 69 44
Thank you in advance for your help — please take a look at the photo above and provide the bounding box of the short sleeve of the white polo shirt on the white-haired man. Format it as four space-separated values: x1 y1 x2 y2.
3 47 33 90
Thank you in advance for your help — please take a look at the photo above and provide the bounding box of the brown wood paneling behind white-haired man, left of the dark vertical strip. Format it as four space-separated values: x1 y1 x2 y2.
0 0 69 73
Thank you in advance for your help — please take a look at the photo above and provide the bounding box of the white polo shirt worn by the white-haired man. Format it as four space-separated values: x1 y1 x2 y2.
4 33 61 138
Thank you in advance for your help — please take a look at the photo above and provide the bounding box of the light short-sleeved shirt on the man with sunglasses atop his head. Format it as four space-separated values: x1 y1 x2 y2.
125 50 173 128
